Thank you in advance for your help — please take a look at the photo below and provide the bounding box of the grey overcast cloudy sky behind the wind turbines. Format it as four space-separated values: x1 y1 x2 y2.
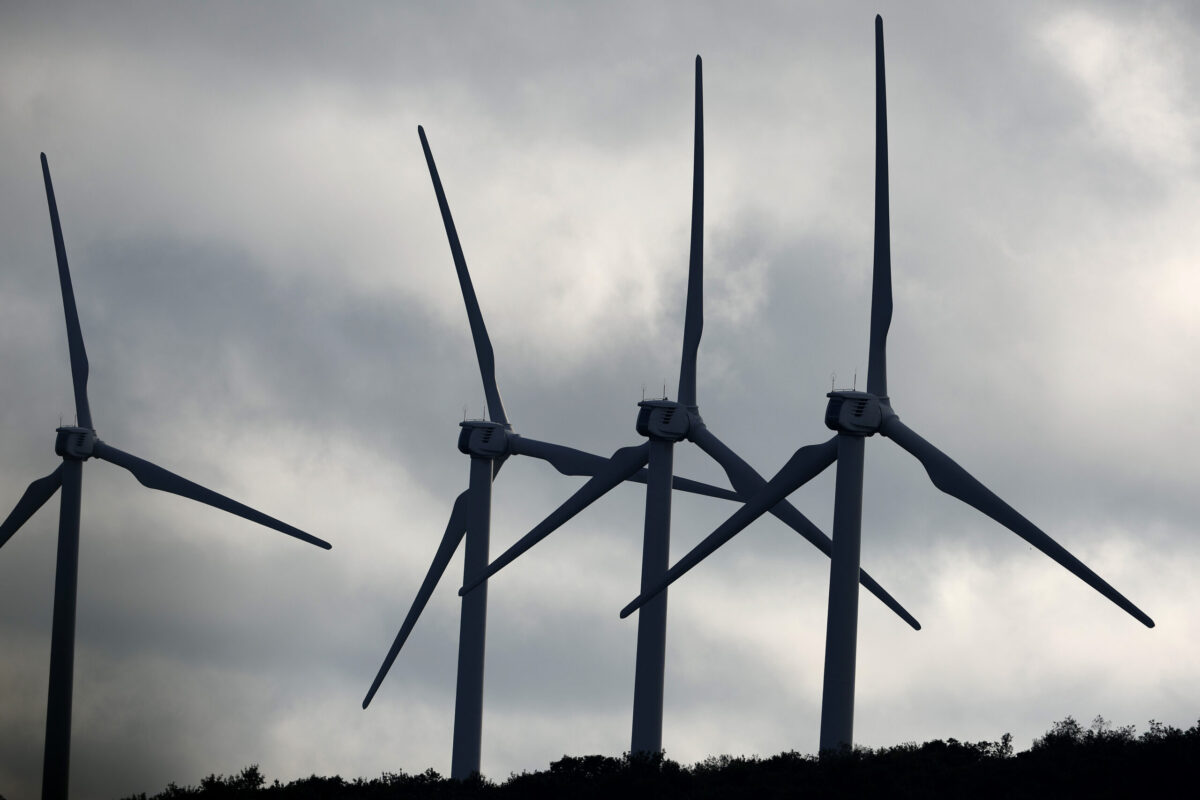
0 1 1200 798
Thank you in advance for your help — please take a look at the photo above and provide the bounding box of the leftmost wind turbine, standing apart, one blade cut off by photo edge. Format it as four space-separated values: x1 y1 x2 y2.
0 152 331 800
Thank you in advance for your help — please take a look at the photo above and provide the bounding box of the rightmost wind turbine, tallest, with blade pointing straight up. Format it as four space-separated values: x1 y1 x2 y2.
620 16 1154 752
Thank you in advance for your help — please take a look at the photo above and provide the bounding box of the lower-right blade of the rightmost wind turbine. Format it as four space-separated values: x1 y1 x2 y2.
881 416 1154 627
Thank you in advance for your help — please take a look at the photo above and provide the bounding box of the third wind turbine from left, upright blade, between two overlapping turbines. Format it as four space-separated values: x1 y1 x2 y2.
460 55 920 753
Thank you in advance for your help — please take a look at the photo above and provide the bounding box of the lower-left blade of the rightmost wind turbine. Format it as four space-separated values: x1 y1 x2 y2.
620 437 838 619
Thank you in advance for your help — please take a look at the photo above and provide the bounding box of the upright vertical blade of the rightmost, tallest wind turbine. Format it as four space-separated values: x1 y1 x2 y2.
866 16 892 397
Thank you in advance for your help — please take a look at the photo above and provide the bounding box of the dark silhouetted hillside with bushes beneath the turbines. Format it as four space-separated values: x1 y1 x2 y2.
126 717 1200 800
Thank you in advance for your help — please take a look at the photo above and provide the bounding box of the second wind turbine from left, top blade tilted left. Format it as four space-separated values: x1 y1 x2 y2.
362 126 749 778
